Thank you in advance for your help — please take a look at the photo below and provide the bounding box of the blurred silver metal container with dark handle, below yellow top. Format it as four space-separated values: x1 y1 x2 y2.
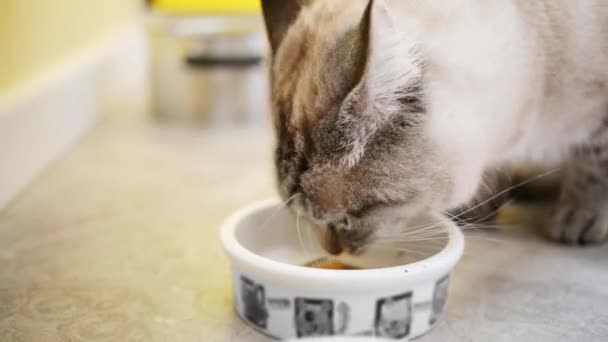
149 16 269 126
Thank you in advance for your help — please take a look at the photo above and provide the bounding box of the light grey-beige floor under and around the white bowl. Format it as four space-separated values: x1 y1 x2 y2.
0 115 608 342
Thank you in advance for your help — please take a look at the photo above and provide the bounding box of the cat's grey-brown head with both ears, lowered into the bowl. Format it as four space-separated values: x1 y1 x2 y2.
262 0 476 254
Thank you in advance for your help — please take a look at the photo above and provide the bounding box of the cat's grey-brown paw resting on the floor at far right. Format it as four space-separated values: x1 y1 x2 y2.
548 203 608 245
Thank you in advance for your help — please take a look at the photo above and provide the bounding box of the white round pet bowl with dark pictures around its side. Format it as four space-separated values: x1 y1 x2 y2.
221 201 464 340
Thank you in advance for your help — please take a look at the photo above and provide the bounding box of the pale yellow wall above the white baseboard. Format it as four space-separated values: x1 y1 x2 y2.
0 0 142 91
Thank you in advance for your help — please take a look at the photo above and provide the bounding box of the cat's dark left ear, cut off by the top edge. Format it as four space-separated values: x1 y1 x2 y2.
262 0 306 53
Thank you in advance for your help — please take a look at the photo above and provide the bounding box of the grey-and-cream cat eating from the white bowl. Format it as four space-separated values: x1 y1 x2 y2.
262 0 608 255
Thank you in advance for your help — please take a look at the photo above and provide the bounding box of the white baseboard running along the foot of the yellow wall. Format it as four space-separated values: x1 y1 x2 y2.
0 26 146 210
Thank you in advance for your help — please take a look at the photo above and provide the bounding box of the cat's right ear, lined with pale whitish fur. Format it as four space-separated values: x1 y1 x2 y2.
337 0 421 167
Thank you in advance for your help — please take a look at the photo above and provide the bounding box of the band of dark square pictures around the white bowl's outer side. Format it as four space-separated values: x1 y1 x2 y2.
235 275 450 340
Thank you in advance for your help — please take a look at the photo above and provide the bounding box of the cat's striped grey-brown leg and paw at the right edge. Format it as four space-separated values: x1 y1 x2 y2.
548 140 608 245
